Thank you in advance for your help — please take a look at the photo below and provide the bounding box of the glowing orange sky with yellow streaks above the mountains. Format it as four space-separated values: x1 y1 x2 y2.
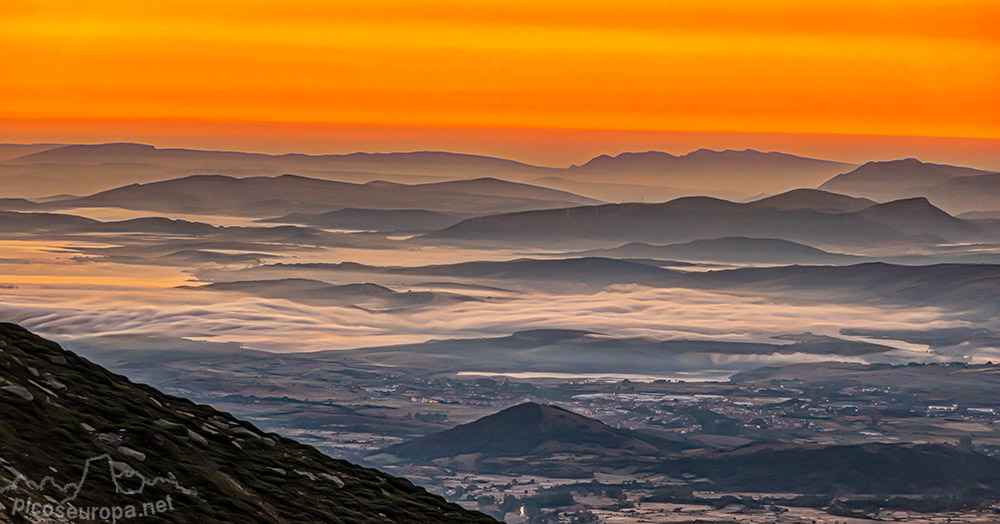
0 0 1000 164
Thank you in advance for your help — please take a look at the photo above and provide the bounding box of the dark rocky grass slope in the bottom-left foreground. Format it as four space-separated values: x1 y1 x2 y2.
0 324 493 524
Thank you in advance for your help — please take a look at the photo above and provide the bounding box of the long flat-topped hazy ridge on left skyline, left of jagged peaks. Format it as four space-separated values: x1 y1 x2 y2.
0 143 549 197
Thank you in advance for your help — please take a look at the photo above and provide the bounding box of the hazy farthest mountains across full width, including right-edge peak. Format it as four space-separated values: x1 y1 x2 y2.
0 143 1000 214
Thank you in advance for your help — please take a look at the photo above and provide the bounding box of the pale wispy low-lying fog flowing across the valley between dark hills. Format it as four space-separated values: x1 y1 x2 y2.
0 237 965 360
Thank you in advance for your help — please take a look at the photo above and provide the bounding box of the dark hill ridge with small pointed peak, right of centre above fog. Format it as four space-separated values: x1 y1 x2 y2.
422 192 984 246
